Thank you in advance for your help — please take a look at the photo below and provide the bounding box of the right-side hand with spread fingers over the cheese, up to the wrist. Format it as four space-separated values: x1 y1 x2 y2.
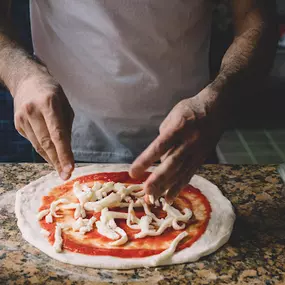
130 88 223 203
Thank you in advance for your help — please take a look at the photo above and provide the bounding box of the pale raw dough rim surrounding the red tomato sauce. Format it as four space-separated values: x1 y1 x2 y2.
15 164 235 269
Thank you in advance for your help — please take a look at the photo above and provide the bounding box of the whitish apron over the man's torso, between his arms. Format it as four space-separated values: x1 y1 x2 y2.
30 0 211 162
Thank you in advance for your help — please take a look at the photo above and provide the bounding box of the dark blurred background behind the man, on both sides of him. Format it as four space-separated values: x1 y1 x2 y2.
0 0 285 164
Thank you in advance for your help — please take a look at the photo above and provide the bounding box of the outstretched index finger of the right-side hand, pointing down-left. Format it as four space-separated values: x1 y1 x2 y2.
129 131 177 178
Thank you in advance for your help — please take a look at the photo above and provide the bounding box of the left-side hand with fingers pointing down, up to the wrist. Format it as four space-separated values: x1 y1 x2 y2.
13 66 74 180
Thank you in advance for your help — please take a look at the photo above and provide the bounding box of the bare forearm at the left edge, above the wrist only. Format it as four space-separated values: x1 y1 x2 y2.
0 18 41 96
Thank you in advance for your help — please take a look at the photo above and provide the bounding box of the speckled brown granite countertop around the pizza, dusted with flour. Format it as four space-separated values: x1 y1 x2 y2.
0 164 285 285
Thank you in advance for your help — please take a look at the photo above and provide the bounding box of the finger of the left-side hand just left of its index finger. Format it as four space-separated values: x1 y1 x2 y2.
28 112 63 176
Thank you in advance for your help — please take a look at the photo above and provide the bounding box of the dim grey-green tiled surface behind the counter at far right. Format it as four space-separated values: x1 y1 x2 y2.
217 128 285 164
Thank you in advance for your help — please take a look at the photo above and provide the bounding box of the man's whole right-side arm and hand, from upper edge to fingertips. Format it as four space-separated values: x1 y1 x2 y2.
130 0 277 202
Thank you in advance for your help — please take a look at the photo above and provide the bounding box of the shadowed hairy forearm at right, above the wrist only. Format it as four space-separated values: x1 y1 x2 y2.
209 2 277 116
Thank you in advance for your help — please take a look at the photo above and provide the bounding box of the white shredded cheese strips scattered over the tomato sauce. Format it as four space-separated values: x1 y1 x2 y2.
37 181 192 256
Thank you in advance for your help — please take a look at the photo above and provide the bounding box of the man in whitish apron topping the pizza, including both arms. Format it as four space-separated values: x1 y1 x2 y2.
0 0 276 203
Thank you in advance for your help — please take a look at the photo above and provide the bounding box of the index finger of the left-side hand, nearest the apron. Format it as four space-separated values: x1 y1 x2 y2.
43 96 74 176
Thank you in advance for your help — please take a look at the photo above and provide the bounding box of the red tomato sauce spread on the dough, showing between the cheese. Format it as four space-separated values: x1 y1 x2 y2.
39 172 211 258
